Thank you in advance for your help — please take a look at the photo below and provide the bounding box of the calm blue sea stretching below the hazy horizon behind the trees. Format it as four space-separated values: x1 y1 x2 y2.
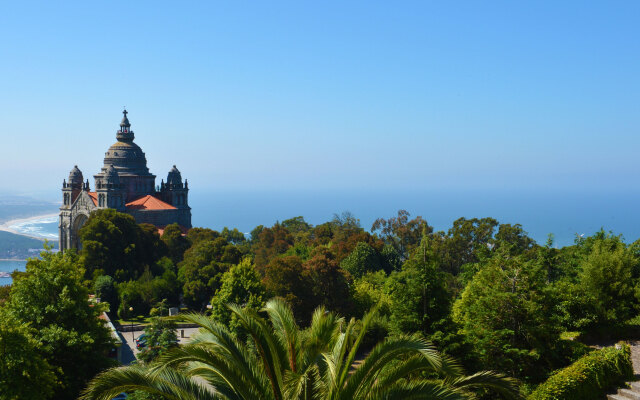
0 189 640 285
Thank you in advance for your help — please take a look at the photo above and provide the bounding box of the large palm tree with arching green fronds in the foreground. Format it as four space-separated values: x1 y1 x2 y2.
82 299 520 400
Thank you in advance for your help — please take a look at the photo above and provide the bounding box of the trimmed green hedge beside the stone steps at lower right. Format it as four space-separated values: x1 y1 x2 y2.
529 344 633 400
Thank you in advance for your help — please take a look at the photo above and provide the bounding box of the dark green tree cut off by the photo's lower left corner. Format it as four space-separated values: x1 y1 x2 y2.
0 308 56 400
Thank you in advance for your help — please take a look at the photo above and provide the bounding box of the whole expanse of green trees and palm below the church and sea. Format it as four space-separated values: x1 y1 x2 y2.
0 209 640 399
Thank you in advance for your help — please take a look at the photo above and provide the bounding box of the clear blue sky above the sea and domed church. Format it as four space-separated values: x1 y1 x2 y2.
0 1 640 198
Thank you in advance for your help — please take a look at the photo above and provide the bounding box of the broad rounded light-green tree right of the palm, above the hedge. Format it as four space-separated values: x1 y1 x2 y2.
453 251 561 382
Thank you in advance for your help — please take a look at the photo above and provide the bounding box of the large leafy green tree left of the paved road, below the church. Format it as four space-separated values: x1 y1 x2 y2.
5 251 113 399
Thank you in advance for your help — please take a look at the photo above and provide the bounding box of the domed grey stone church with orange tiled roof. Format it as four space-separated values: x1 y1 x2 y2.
59 110 191 251
